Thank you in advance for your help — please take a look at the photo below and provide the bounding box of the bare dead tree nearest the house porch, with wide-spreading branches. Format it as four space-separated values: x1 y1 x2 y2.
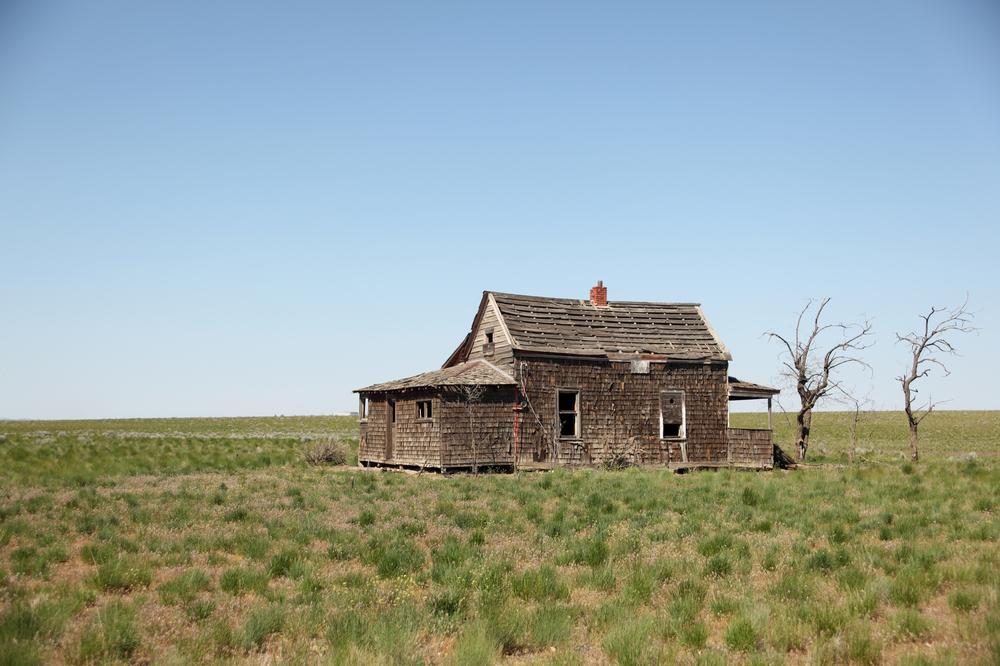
765 298 873 460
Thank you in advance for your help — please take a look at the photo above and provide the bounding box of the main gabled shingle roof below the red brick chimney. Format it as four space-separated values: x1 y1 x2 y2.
484 292 732 361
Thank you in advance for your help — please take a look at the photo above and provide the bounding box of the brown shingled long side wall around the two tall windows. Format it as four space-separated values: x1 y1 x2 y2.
515 357 728 464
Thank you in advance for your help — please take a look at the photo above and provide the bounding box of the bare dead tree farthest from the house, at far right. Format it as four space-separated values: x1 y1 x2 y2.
896 298 976 462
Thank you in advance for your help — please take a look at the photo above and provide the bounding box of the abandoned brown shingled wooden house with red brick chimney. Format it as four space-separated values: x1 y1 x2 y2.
355 282 778 471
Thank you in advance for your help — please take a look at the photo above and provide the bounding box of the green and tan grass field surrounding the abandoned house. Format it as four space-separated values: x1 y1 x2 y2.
0 412 1000 664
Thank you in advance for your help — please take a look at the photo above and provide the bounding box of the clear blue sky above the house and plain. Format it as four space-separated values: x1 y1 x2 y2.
0 0 1000 418
